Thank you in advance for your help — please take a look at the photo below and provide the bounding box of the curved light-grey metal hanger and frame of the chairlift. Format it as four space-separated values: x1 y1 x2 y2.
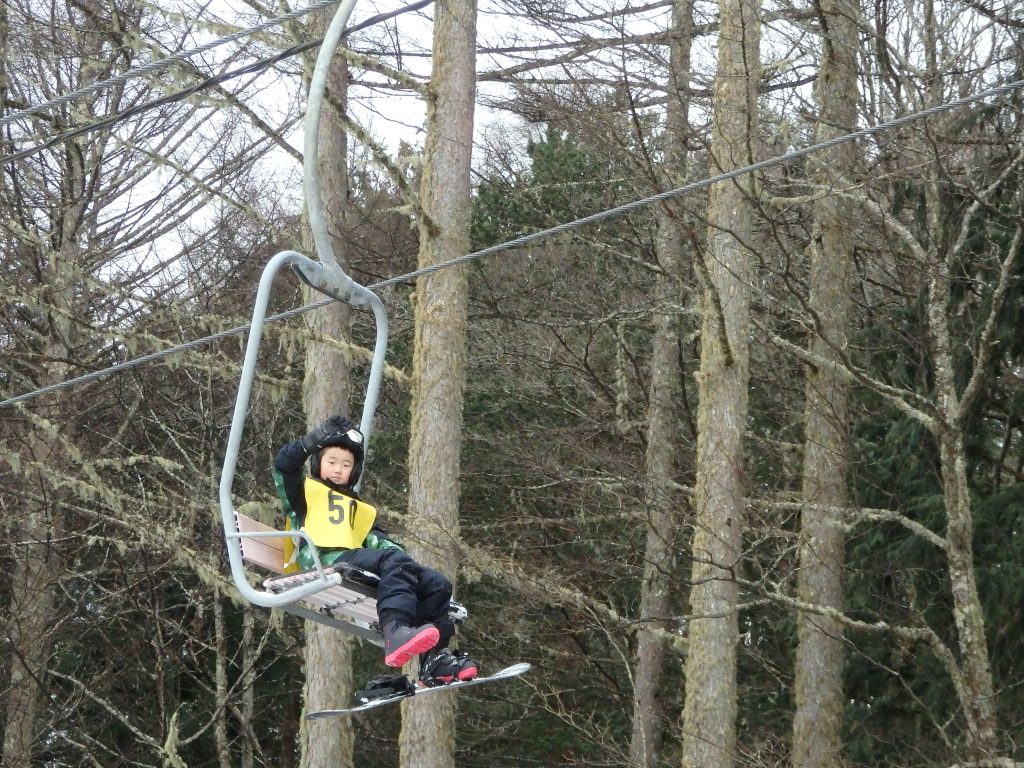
220 0 388 618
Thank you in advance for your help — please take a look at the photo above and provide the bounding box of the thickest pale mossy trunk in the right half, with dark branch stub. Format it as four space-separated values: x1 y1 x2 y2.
682 0 761 768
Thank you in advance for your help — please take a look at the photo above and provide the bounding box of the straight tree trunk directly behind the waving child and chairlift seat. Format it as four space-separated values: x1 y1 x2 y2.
300 13 358 768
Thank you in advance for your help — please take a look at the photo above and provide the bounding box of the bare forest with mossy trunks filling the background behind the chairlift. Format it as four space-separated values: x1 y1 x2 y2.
0 0 1024 768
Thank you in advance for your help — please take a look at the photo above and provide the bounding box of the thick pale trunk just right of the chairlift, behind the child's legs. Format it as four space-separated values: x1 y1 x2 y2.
400 0 476 768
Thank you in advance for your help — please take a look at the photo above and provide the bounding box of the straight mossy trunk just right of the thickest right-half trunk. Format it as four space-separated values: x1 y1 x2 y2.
793 0 860 768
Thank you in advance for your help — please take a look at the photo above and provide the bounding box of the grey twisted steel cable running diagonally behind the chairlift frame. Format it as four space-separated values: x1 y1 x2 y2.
0 71 1024 408
